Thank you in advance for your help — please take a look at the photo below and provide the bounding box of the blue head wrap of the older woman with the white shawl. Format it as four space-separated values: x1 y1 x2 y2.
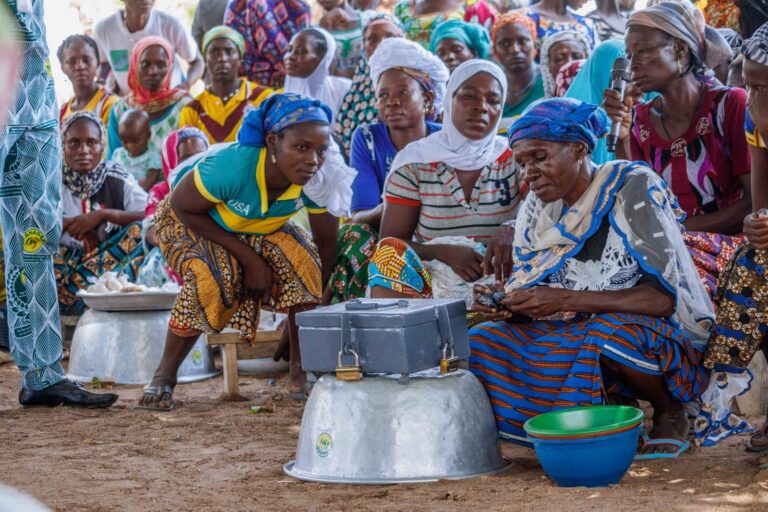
509 98 610 151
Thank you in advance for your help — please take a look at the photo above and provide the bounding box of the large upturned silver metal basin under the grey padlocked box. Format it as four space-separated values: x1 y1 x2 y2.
283 370 509 484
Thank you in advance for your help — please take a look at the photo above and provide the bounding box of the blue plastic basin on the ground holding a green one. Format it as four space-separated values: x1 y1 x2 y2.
529 424 642 487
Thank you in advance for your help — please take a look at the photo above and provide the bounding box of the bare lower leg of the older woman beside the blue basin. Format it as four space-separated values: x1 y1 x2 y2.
600 356 690 453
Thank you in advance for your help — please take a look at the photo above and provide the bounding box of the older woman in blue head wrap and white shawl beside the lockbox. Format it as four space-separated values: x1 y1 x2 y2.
470 98 714 458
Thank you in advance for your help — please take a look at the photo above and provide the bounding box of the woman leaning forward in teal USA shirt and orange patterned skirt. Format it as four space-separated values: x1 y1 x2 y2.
139 94 338 410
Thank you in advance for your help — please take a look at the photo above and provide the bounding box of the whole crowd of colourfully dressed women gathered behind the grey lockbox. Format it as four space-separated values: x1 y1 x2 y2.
15 0 768 464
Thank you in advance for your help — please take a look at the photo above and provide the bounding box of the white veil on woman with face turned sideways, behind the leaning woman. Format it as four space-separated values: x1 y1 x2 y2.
284 27 352 124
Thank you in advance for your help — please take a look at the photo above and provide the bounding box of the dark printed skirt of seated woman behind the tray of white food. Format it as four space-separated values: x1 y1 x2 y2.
54 222 144 316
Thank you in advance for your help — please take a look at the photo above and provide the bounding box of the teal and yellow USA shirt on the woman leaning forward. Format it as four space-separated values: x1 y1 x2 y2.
176 143 326 235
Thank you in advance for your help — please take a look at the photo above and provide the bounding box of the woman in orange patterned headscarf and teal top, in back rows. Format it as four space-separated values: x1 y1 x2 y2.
491 11 544 133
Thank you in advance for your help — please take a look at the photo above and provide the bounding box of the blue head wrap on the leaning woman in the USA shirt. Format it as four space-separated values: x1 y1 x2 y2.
237 93 333 147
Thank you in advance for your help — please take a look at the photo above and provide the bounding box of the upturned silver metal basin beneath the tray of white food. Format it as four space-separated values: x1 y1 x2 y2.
68 309 218 384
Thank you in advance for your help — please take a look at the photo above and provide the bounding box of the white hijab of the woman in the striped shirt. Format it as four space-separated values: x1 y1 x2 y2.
391 59 508 171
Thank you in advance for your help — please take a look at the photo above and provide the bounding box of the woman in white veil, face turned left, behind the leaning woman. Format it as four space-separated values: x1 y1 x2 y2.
285 27 352 125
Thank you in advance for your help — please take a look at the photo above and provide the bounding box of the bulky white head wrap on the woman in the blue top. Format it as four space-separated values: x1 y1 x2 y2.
368 37 449 114
